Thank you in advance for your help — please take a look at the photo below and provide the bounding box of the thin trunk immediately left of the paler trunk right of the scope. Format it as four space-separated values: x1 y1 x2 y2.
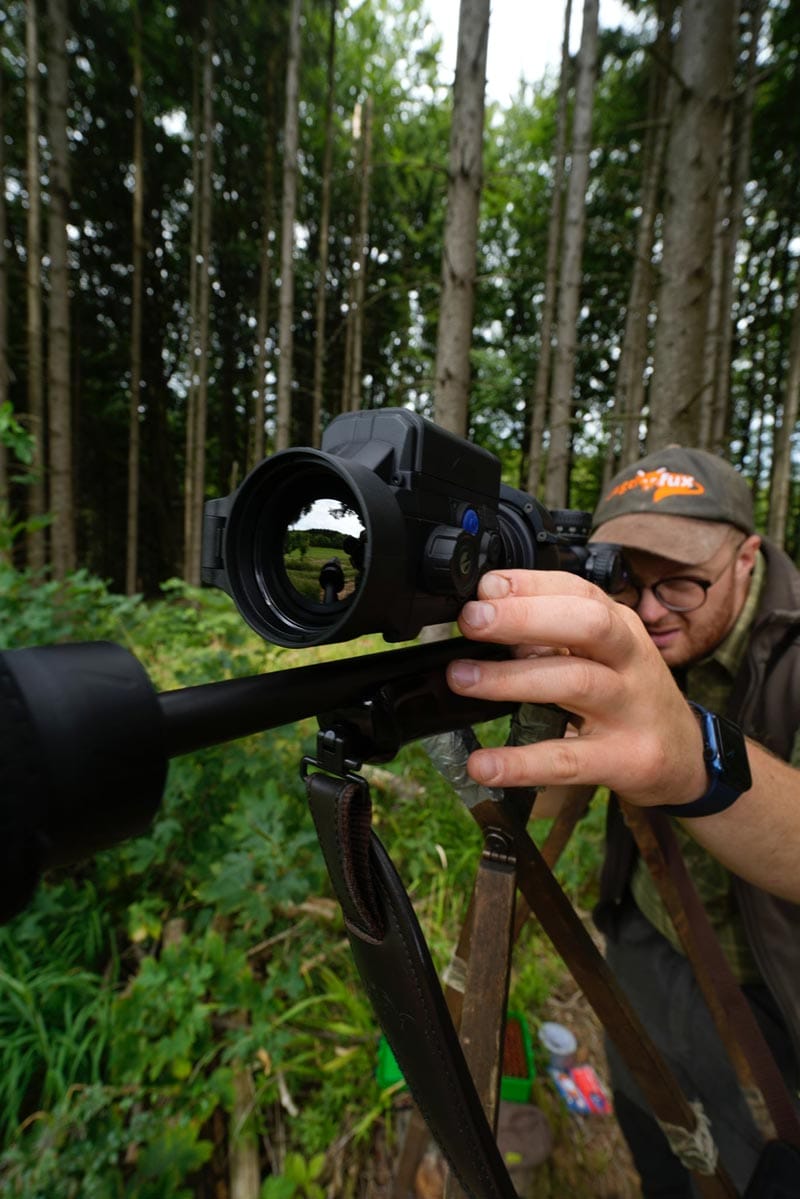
528 0 572 495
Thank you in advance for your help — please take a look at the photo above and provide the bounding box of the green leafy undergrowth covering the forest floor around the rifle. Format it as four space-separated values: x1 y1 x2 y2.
0 567 622 1199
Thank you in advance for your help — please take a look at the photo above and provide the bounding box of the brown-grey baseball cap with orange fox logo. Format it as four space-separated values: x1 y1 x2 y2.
591 446 754 566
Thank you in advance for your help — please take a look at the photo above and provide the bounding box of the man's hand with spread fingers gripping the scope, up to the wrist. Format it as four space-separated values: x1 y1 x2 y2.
447 571 708 806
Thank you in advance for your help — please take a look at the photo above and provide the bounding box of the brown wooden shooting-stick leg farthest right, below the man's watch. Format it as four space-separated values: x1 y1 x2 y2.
622 805 800 1147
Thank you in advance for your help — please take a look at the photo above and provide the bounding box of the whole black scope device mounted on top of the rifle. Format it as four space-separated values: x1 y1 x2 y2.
201 409 615 646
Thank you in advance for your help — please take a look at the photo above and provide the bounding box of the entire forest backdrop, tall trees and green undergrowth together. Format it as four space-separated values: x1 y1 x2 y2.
0 0 800 1199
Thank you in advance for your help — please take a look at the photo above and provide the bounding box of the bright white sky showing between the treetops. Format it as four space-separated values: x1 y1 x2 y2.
427 0 634 104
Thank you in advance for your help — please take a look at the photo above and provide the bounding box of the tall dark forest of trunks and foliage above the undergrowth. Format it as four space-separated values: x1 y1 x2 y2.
0 0 800 595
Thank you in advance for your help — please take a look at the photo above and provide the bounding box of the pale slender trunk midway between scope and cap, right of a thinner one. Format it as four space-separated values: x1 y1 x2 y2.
545 0 599 508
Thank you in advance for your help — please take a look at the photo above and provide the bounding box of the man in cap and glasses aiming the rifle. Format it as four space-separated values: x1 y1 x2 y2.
449 447 800 1199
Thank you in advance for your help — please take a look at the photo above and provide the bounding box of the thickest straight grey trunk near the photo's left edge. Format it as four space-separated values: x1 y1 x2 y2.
47 0 77 579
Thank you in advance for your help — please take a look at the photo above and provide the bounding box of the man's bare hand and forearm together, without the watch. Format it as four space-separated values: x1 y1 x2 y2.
447 571 800 903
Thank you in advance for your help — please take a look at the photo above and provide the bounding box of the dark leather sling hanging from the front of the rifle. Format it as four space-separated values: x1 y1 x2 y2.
306 772 517 1199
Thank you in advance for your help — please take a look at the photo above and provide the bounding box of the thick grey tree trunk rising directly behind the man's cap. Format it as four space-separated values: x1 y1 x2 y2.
648 0 734 450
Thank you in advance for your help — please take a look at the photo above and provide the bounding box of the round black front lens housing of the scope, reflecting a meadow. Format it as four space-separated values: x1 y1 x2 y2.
204 450 405 645
